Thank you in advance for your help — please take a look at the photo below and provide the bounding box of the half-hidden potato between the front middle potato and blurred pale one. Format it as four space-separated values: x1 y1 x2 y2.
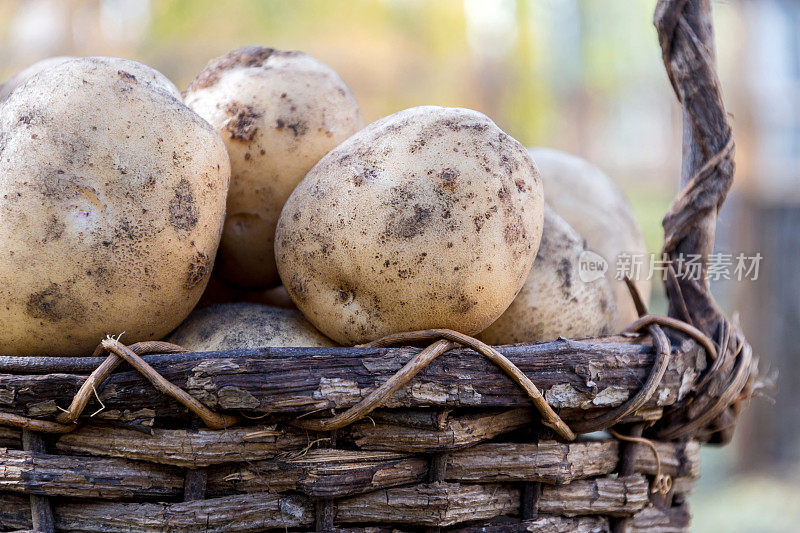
479 206 617 344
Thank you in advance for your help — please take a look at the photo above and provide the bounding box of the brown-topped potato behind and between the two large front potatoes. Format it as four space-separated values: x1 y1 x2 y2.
185 46 364 288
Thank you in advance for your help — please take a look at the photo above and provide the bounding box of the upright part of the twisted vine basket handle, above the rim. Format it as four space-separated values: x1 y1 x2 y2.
654 0 734 338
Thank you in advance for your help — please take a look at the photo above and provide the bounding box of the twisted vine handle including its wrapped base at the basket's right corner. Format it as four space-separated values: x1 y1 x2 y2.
654 0 758 442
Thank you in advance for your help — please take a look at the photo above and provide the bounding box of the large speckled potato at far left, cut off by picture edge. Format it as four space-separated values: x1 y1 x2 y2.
0 58 230 355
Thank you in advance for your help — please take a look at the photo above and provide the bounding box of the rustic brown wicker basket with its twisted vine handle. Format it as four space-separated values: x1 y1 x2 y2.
0 0 757 532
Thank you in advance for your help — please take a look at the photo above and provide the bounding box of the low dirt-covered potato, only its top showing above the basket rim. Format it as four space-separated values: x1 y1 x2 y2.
167 303 335 352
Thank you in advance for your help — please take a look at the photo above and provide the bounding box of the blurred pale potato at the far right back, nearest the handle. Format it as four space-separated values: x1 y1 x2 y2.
530 148 650 330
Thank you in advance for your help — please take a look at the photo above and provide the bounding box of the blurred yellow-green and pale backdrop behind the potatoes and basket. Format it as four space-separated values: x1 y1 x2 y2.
0 0 800 531
